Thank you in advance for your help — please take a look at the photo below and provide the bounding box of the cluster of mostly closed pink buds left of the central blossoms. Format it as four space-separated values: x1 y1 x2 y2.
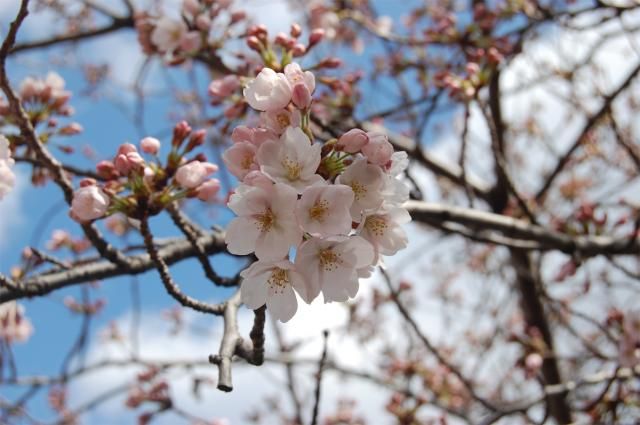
70 121 220 222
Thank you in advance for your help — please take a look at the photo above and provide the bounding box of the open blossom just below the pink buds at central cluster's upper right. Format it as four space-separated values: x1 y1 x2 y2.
336 157 385 223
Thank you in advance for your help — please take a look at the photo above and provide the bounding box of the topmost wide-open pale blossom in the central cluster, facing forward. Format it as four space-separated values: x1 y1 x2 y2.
257 127 323 193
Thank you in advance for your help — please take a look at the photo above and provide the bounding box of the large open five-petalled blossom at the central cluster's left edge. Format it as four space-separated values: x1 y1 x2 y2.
225 183 302 260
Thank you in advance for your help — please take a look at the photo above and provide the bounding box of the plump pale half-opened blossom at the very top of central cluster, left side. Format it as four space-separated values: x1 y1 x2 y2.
244 68 291 111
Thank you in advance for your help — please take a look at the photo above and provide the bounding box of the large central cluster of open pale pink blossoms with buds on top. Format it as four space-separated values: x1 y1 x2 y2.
223 64 411 322
